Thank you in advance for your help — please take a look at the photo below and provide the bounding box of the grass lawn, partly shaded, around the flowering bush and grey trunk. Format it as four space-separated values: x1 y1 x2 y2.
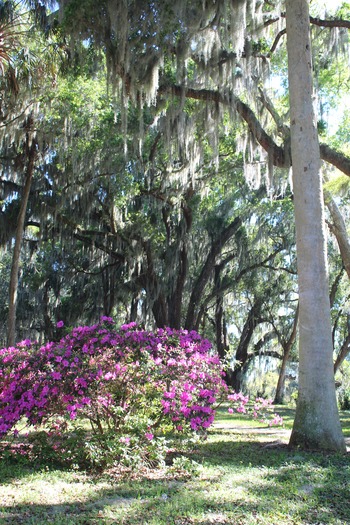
0 408 350 525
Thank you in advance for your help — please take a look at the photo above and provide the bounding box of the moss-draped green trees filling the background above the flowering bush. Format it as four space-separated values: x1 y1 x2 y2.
0 0 350 450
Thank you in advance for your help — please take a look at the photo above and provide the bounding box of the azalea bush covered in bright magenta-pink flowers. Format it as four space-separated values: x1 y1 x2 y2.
0 317 280 466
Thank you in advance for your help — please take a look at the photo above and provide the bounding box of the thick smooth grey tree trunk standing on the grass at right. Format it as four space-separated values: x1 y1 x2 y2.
286 0 346 451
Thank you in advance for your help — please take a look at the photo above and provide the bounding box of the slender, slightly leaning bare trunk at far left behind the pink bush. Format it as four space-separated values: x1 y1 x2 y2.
7 137 37 346
